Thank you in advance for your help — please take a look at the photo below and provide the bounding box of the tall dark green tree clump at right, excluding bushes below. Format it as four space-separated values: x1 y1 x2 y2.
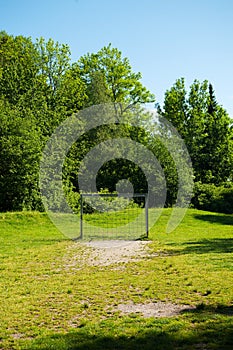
162 79 232 185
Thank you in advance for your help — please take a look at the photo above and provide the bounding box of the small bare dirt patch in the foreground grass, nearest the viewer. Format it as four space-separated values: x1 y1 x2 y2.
116 301 194 317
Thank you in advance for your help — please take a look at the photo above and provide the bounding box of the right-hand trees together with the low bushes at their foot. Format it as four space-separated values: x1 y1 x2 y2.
161 79 233 213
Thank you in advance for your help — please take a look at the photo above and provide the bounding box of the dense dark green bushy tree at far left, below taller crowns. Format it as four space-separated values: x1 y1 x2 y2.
0 100 42 211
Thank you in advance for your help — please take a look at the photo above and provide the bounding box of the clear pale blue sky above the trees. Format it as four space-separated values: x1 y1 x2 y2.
0 0 233 118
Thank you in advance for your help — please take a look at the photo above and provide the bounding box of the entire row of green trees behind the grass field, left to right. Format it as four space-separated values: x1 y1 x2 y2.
0 32 233 212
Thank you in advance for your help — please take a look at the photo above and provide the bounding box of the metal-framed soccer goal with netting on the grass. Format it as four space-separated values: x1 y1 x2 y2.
80 193 148 240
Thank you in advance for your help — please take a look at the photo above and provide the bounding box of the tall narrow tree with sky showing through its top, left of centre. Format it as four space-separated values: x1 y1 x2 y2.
35 38 87 121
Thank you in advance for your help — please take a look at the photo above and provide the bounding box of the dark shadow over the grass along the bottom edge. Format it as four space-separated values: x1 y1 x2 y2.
21 309 233 350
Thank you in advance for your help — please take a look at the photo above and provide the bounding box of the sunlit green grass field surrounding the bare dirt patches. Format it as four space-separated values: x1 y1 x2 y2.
0 209 233 350
